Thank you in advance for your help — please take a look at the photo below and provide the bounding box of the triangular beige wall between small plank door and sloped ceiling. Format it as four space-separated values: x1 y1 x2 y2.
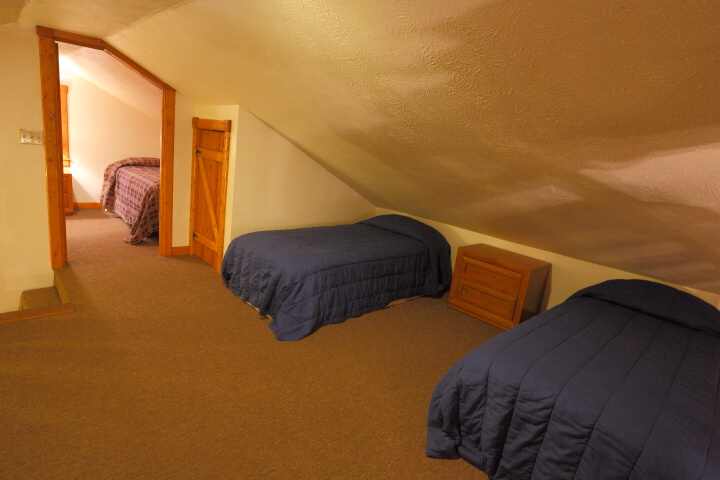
190 105 375 253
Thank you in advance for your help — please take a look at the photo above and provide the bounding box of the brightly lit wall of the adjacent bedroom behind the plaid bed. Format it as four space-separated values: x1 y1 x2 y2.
60 69 161 202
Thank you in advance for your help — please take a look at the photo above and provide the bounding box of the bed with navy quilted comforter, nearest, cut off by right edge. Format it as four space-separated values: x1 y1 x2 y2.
426 280 720 480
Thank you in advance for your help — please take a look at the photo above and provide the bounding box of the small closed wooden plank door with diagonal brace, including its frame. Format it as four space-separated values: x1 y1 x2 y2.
190 118 230 273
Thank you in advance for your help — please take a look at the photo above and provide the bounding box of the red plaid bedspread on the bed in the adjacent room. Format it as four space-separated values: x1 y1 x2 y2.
100 157 160 244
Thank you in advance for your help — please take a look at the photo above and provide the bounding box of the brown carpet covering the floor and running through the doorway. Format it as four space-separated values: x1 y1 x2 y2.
0 210 499 479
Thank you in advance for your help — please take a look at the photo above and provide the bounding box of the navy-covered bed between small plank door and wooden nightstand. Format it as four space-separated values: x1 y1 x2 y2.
222 215 452 340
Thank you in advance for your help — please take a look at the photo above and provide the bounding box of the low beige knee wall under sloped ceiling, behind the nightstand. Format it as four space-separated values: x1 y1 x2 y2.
376 208 720 308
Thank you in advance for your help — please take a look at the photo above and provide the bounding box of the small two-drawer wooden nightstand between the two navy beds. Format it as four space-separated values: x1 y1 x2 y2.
449 243 550 330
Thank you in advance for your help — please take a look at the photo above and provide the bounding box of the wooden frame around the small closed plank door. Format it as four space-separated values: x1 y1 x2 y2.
188 117 232 273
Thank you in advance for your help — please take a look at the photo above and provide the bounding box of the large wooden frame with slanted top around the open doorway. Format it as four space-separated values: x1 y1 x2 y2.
36 25 175 268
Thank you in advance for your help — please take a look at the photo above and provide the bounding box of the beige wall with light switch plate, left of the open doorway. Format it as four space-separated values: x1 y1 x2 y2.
0 25 53 312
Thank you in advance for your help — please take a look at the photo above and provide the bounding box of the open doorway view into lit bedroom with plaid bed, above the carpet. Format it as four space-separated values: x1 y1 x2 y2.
58 43 162 243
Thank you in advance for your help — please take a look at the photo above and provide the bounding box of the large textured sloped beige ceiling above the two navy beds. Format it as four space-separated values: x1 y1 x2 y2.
9 0 720 293
